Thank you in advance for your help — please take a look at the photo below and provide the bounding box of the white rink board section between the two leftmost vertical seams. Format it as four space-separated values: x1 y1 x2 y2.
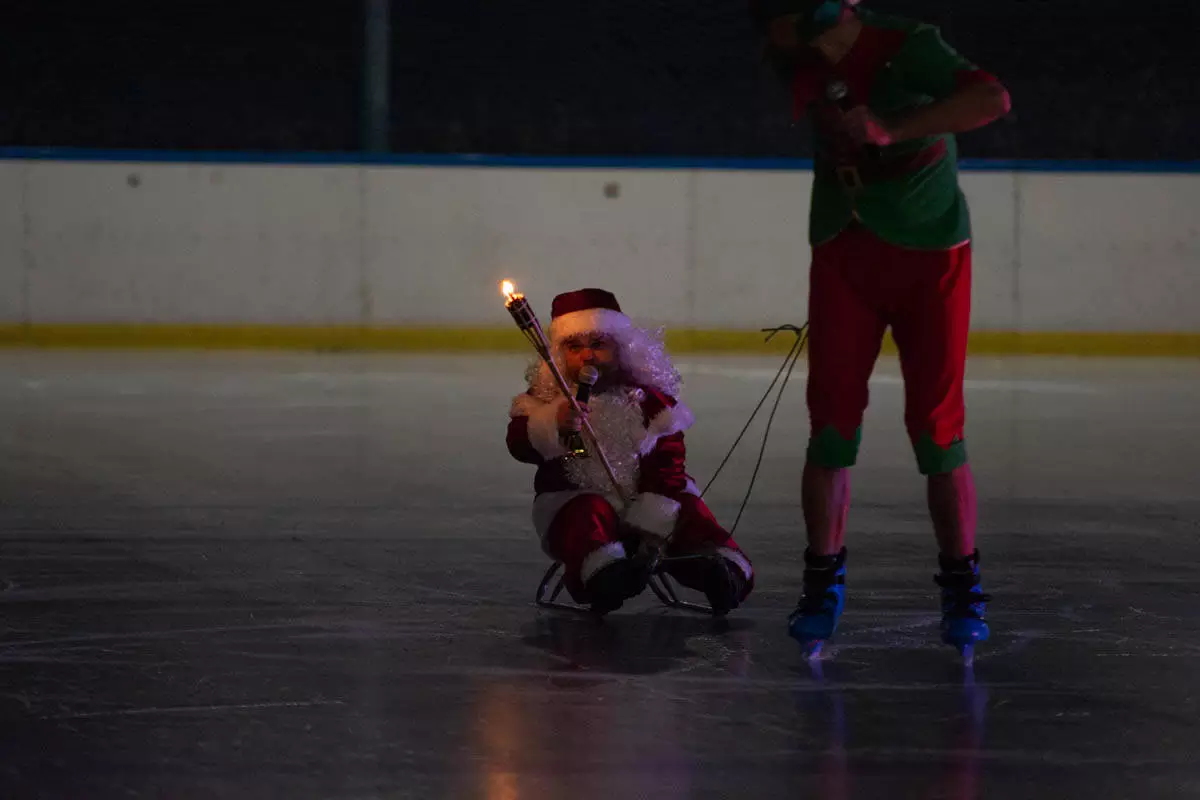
16 163 362 324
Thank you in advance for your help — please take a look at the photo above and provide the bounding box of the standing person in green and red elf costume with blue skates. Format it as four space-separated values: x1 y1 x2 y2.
750 0 1009 649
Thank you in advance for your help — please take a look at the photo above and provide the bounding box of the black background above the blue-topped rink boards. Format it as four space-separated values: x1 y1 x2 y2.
0 0 1200 161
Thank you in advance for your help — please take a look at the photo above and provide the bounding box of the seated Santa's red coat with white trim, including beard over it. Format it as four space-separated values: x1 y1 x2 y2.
508 384 700 541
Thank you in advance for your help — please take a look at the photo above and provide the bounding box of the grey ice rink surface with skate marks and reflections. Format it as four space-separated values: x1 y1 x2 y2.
0 350 1200 800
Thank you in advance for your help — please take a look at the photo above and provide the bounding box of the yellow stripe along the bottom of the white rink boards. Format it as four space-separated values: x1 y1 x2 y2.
0 324 1200 357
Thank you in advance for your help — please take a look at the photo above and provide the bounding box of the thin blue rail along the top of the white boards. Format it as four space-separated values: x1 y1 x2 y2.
0 148 1200 174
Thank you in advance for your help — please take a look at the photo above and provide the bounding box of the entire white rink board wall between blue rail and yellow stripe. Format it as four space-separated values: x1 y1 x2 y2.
0 161 1200 332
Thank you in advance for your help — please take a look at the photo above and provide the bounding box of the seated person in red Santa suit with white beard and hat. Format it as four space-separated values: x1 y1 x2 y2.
508 289 754 615
